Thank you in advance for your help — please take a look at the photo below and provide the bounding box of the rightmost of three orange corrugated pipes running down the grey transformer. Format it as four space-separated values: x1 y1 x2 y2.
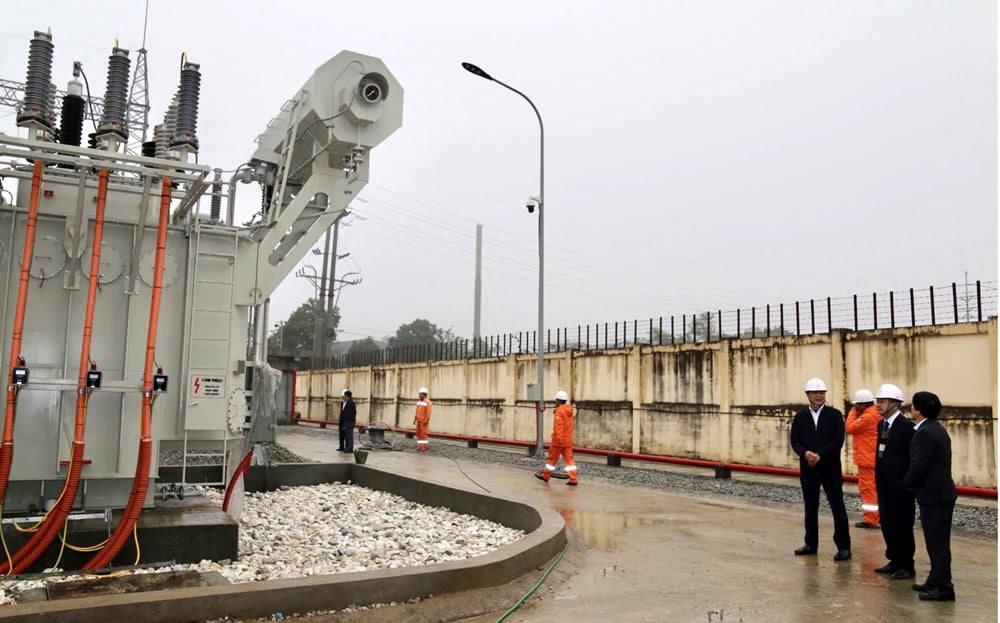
83 177 171 569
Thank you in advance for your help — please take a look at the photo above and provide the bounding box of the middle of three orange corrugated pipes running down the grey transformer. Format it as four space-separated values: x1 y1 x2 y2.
0 169 108 575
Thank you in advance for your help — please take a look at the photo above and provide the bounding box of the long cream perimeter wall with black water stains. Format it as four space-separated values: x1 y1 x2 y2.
296 318 997 488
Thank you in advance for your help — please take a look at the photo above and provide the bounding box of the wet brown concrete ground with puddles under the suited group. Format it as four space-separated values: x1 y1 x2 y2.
277 430 997 623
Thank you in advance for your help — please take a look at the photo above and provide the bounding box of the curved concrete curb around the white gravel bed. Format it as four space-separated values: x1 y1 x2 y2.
0 464 566 623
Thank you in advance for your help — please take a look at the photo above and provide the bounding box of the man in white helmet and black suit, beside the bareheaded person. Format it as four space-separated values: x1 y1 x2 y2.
875 383 916 580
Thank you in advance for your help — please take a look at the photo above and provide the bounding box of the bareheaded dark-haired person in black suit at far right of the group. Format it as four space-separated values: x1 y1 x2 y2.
903 392 958 601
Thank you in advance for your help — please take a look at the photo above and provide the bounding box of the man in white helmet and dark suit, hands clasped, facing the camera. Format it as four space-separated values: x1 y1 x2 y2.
791 378 851 560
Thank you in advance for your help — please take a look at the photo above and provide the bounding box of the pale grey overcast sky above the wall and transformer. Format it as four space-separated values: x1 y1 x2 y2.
0 0 997 340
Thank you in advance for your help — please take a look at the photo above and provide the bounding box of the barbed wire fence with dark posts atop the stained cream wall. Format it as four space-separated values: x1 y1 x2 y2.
330 281 997 369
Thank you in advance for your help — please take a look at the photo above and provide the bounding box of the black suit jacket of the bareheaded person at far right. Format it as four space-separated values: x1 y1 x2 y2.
903 420 958 504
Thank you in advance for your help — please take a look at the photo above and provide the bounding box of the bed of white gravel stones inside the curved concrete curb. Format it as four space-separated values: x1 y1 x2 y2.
0 483 524 604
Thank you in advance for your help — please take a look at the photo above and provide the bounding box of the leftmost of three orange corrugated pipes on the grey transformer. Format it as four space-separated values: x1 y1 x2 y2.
0 160 45 502
